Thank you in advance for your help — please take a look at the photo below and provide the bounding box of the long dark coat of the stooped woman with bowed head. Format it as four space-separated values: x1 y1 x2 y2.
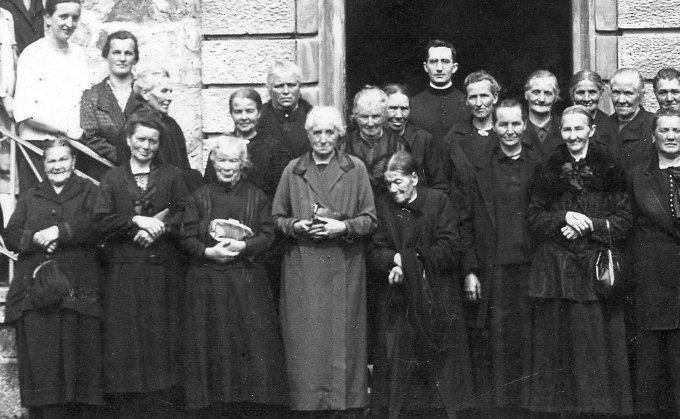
369 188 472 418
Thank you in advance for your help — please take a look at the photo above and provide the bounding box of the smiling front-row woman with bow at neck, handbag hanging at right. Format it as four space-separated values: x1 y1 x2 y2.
524 105 633 415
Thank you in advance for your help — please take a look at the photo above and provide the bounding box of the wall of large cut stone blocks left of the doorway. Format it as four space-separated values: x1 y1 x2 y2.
201 0 321 151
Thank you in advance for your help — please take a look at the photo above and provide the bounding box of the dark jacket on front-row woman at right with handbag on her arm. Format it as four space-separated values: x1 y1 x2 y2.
527 142 633 301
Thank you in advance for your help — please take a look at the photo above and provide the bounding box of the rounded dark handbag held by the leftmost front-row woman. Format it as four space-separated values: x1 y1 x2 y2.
29 256 71 308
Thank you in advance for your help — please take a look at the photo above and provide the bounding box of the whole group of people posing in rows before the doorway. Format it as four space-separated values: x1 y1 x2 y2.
0 0 680 419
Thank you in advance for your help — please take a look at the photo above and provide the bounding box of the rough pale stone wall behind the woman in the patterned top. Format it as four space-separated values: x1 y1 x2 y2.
73 0 203 171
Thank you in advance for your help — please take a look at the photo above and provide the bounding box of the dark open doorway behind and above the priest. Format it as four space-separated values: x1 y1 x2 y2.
346 0 573 110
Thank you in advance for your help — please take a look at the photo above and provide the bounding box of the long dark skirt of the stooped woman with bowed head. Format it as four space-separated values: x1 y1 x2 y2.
371 286 473 418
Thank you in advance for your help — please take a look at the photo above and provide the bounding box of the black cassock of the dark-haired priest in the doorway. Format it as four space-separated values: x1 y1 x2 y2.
408 86 470 151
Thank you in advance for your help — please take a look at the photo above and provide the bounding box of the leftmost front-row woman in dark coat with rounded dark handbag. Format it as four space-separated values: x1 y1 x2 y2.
3 140 103 418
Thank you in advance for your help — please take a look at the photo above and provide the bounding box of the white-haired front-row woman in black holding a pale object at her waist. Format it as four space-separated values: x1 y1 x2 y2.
182 136 288 417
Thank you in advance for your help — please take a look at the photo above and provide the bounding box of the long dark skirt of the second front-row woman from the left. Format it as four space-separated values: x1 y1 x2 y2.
104 263 183 393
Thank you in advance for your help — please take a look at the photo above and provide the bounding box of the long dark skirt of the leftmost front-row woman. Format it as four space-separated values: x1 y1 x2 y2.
17 309 103 407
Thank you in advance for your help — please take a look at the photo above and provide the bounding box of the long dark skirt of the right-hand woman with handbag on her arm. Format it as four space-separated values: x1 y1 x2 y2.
523 299 632 415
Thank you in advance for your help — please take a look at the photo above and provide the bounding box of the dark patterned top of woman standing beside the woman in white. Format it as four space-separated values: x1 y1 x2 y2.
80 77 135 164
